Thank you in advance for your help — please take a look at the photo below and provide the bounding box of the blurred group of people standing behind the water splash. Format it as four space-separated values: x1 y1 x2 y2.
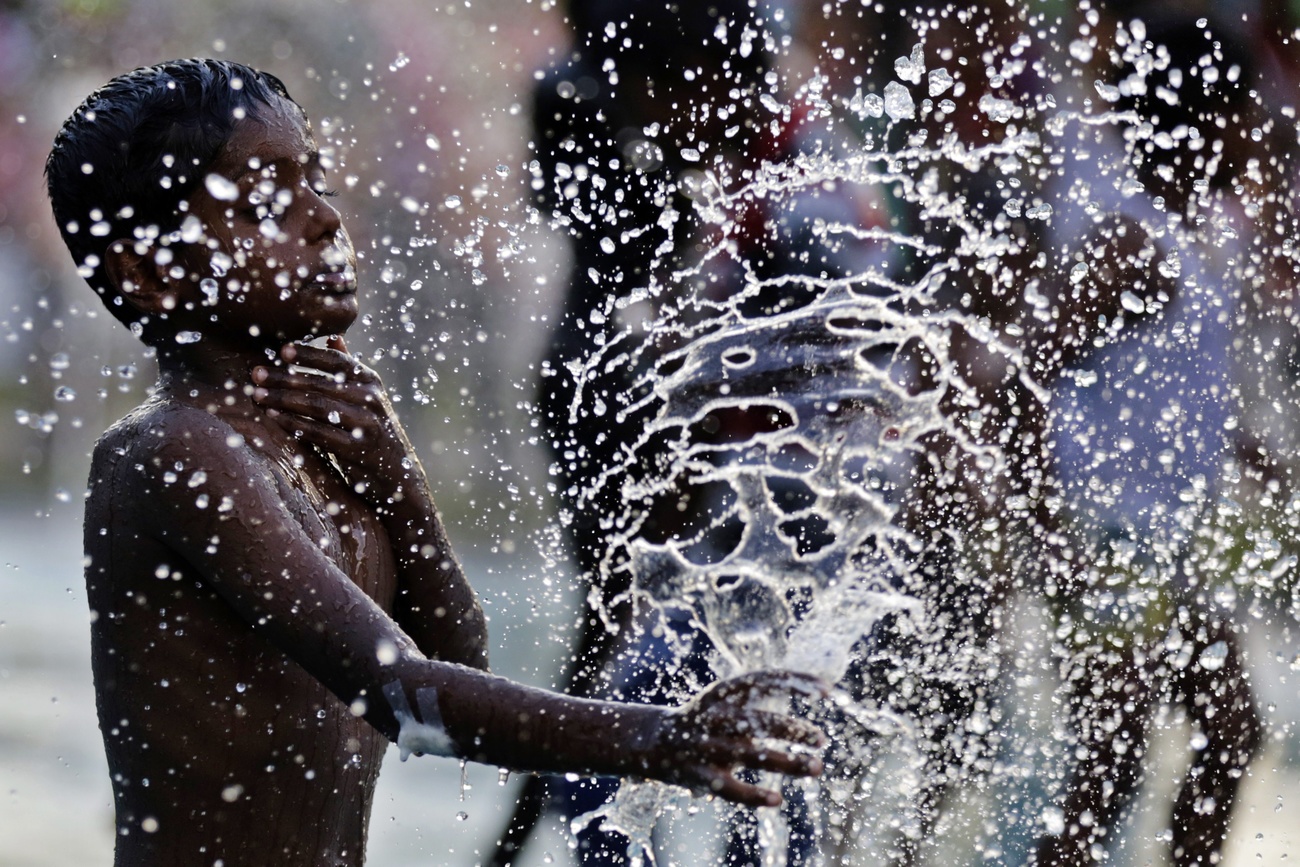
498 0 1300 864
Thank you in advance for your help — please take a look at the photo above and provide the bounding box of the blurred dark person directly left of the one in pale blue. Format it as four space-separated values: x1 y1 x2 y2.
806 3 1071 864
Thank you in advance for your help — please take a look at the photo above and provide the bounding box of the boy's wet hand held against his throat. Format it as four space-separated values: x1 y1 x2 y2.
252 337 425 506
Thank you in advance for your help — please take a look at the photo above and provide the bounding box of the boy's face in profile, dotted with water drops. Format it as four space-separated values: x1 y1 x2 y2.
174 99 358 343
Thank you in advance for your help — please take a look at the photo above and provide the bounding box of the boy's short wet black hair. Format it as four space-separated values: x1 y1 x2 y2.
46 58 302 324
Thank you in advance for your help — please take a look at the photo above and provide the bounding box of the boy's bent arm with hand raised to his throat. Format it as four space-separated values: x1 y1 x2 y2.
252 337 488 671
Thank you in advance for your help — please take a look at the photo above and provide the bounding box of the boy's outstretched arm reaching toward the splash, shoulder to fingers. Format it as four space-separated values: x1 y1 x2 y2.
131 409 823 806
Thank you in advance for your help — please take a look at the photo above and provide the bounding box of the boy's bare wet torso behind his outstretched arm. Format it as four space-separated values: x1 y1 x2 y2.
86 399 397 867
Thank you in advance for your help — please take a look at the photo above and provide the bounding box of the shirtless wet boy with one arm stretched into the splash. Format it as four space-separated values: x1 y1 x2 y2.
46 60 822 867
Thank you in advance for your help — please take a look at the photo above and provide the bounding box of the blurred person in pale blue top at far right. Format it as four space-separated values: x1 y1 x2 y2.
1036 10 1260 867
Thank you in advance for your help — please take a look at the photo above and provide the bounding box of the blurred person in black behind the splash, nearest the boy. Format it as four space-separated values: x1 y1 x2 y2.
488 0 800 864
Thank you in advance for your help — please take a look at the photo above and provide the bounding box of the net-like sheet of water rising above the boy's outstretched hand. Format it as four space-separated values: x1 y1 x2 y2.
553 55 1164 863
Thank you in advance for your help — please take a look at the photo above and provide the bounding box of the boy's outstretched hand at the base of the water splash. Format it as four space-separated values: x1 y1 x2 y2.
645 672 827 807
